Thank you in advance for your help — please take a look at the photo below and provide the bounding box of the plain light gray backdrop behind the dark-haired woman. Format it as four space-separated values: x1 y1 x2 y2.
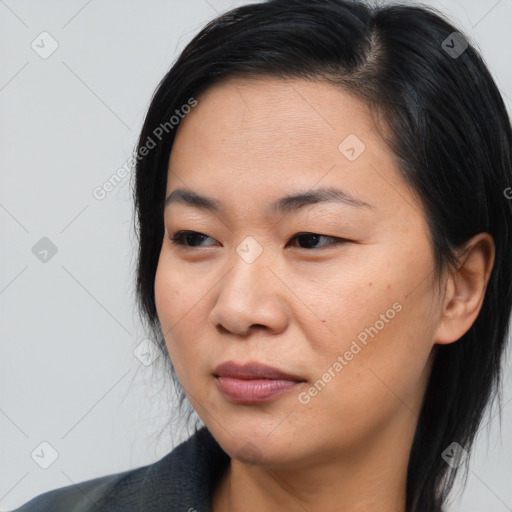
0 0 512 512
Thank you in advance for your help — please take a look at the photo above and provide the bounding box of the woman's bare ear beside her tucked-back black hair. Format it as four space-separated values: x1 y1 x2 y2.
434 233 495 344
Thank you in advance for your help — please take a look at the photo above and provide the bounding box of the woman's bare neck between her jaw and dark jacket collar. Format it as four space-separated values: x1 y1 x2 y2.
212 412 415 512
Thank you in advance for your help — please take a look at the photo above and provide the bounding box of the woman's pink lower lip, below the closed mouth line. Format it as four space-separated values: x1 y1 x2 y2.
215 377 301 403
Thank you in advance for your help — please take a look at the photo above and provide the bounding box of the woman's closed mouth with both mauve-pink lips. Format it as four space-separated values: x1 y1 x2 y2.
213 361 306 404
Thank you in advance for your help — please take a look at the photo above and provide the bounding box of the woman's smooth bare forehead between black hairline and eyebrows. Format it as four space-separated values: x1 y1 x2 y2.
167 77 422 220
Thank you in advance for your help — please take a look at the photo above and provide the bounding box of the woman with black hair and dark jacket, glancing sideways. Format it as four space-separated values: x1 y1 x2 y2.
11 0 512 512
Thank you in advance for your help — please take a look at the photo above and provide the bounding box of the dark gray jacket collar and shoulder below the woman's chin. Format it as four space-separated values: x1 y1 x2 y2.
12 427 230 512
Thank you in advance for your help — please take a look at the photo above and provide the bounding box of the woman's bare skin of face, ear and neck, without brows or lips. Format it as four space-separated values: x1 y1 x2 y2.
155 77 494 512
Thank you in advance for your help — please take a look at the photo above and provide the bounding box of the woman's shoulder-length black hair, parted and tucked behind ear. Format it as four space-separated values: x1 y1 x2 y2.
134 0 512 512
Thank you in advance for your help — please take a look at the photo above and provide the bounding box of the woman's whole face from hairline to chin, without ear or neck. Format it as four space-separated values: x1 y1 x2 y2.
155 78 441 467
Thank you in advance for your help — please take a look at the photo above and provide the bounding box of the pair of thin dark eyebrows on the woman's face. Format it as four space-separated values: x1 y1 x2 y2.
165 187 373 215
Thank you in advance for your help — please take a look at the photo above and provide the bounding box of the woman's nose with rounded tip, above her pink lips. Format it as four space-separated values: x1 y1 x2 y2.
209 245 290 337
